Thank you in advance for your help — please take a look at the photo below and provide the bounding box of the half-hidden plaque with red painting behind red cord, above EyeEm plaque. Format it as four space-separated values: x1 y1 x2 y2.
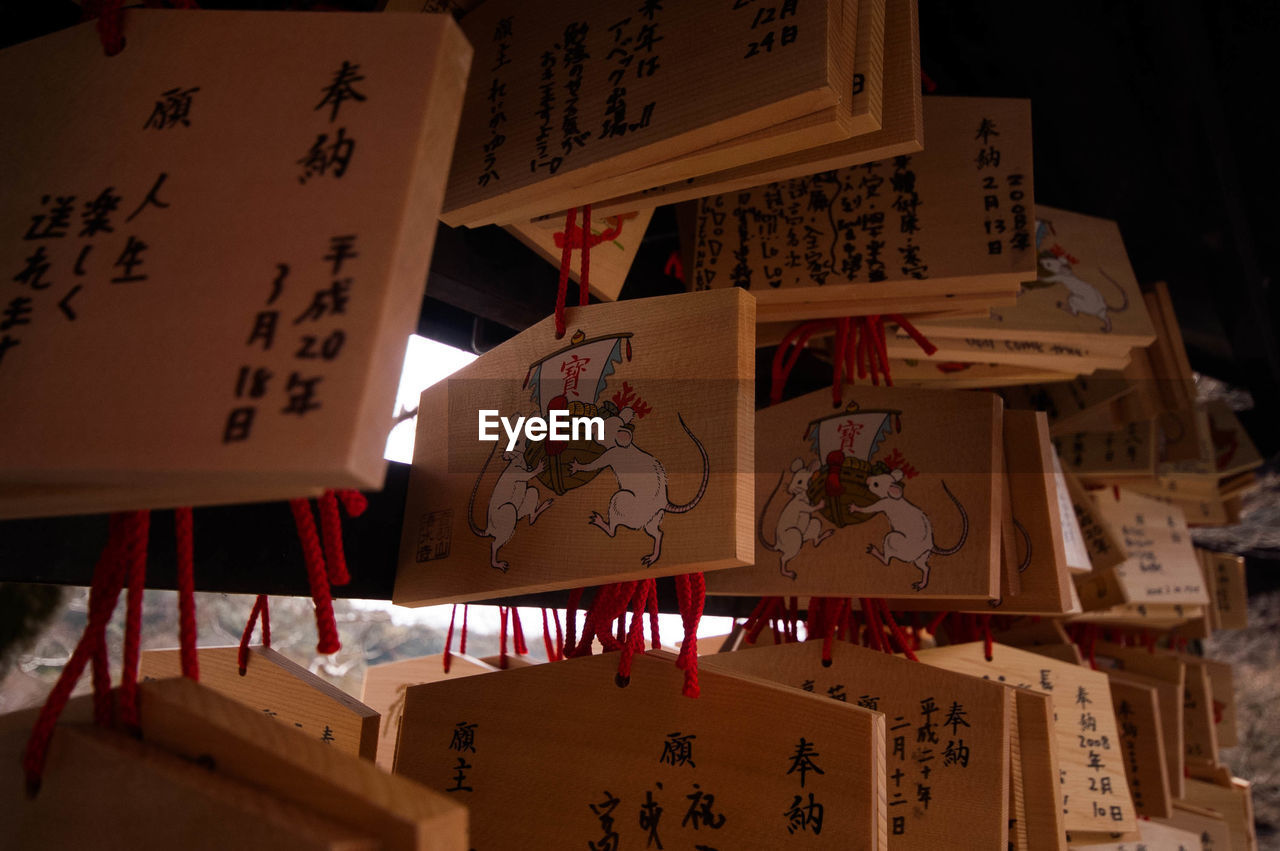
507 210 653 302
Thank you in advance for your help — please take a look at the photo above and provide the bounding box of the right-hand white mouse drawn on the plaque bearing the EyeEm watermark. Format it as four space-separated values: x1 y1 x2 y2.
568 408 710 566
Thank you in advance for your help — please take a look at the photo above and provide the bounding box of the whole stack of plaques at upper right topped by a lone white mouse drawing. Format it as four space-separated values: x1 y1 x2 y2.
890 205 1156 378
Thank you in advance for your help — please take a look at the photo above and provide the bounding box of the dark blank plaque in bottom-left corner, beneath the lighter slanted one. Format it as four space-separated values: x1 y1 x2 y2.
0 713 380 851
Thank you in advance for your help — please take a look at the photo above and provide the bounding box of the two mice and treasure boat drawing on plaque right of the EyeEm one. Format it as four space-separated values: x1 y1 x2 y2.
756 402 969 591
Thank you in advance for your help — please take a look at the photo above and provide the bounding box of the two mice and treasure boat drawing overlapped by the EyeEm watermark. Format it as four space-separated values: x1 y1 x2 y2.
467 330 710 573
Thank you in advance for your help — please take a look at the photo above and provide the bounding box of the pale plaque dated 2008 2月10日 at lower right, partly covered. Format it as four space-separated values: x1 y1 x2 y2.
916 641 1135 832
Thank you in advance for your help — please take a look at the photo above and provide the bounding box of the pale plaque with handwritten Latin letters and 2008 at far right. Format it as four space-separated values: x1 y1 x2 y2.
1076 489 1208 610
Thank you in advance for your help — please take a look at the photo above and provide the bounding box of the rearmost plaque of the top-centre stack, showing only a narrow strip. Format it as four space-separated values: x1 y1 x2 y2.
593 0 924 215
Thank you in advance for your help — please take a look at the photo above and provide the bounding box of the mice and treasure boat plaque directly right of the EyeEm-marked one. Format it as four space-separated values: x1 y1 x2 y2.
707 386 1001 603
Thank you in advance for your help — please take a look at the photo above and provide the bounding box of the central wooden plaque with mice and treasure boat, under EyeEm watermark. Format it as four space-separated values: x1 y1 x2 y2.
394 286 755 605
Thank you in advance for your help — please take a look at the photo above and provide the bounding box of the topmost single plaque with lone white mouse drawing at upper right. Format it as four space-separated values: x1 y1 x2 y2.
918 205 1156 349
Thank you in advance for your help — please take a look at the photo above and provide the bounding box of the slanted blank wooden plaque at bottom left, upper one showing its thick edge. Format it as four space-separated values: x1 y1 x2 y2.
140 678 471 851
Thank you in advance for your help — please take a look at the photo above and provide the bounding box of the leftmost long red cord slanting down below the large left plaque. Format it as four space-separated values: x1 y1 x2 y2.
22 514 127 796
